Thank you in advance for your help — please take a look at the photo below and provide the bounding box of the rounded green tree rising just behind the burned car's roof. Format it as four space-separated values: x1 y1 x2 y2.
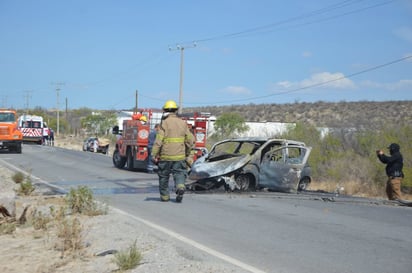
214 113 249 139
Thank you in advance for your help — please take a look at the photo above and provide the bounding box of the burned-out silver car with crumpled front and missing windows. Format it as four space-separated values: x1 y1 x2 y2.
187 137 311 192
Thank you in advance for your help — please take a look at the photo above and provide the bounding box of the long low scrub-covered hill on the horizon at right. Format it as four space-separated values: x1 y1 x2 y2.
187 101 412 129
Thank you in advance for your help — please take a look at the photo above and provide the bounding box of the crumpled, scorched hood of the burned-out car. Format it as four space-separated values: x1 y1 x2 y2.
189 155 252 180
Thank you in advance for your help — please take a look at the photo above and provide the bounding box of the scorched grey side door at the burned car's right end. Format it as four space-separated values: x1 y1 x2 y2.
258 145 311 192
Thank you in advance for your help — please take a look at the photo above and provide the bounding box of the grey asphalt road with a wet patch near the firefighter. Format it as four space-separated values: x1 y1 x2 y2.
0 145 412 273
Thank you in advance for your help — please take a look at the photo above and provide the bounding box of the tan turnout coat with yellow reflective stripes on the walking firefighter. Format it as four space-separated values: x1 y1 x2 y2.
152 113 194 161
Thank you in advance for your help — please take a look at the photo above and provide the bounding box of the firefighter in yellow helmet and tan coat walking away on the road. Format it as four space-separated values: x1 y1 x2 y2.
151 100 194 203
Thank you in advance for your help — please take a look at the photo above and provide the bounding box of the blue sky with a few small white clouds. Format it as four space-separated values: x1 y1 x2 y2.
0 0 412 110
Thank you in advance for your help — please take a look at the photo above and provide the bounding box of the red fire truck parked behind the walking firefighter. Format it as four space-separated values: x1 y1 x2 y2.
112 110 210 170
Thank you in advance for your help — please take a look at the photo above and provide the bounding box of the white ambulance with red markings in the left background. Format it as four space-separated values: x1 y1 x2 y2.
18 115 47 144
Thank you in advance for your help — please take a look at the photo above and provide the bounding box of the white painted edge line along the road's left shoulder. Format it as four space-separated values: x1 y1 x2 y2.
0 159 265 273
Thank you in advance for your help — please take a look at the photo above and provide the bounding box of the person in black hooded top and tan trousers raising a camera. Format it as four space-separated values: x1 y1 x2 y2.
376 143 404 200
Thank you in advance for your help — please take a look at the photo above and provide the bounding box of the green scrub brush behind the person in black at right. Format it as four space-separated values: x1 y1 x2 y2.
279 123 412 197
